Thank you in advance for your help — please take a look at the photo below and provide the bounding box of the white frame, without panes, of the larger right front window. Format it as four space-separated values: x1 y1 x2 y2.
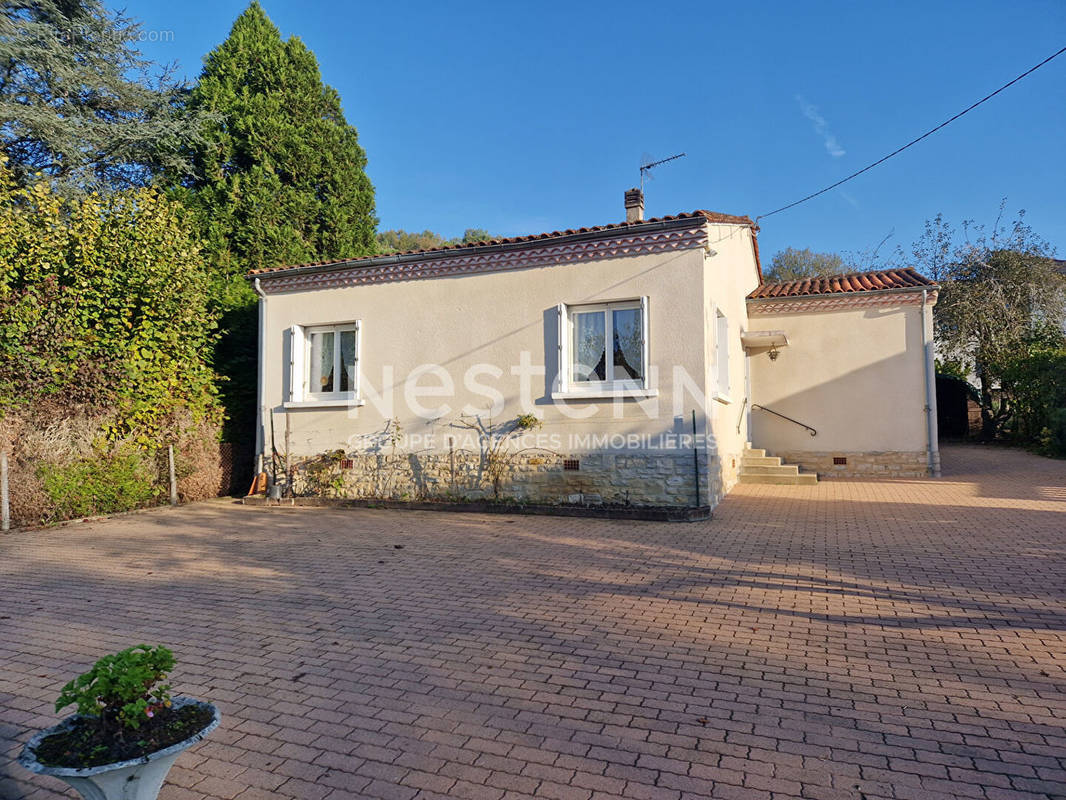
552 295 658 399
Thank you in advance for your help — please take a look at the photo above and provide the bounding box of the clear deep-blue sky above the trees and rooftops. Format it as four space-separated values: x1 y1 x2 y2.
124 0 1066 259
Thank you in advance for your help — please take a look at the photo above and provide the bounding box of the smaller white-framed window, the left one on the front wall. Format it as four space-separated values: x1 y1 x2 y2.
289 321 360 405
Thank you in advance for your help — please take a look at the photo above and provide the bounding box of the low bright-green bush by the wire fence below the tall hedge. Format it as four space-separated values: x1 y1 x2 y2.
39 445 158 519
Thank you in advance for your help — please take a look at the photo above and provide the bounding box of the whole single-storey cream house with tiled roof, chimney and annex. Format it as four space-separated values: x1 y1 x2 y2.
249 190 938 507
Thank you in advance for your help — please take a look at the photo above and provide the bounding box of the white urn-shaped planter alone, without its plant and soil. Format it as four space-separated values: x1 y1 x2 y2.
18 698 221 800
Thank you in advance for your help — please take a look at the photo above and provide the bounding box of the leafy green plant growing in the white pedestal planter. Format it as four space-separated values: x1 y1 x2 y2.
55 644 174 730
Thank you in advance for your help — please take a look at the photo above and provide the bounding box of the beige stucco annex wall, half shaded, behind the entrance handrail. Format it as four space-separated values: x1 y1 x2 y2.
749 293 927 453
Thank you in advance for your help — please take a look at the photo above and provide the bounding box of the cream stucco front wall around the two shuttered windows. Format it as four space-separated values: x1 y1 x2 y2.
263 243 704 453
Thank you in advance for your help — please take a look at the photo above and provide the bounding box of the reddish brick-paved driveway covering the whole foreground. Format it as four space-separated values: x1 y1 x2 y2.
0 448 1066 800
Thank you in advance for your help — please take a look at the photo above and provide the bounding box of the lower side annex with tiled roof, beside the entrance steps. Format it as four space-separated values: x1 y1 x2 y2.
746 268 940 478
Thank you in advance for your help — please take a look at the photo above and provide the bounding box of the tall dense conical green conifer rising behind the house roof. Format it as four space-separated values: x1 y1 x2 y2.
178 2 376 298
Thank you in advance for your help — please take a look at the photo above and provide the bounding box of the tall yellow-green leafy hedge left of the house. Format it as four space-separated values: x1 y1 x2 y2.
0 164 222 450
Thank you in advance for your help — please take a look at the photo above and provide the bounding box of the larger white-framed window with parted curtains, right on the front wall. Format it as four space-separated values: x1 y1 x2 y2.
555 298 648 395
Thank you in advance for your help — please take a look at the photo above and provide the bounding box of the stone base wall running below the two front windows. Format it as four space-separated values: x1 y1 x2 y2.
293 450 712 507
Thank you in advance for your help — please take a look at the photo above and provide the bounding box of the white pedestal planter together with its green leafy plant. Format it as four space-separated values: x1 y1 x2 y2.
18 644 220 800
